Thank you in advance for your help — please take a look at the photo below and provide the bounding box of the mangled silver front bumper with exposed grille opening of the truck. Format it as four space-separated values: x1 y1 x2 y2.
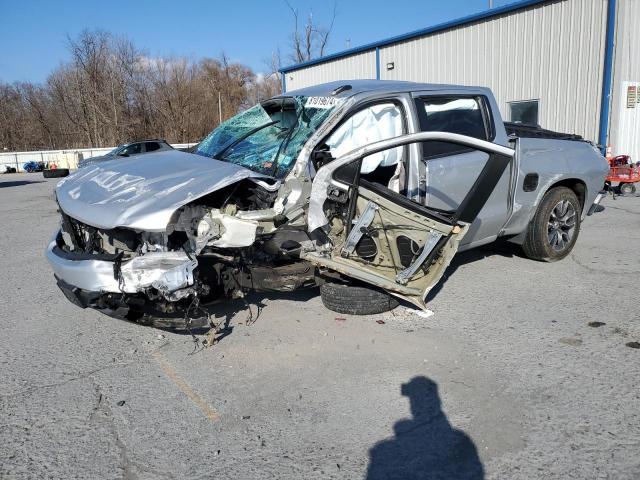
47 213 207 326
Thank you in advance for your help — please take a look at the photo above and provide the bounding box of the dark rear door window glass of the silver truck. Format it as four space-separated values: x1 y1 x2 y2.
416 97 489 158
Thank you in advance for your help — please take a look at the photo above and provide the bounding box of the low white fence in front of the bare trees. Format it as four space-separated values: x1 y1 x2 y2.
0 143 195 173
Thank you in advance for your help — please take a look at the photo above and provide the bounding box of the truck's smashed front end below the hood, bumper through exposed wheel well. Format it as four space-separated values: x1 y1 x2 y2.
46 179 315 328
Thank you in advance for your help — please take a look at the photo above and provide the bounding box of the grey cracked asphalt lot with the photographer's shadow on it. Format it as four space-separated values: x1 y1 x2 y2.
0 174 640 480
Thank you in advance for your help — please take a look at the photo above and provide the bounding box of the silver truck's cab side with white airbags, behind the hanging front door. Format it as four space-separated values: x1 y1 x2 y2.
301 82 512 249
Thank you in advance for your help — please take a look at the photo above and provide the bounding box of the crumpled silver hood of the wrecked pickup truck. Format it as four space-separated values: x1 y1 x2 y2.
56 150 264 232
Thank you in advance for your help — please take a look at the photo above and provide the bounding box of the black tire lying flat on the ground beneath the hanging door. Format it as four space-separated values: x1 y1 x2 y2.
320 282 398 315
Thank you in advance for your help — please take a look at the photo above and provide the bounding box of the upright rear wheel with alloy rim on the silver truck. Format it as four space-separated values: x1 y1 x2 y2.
522 187 582 262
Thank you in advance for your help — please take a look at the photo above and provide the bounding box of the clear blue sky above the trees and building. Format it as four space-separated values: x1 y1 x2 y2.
0 0 514 83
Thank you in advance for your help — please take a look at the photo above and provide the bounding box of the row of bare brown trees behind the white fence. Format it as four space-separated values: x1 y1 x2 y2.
0 31 288 150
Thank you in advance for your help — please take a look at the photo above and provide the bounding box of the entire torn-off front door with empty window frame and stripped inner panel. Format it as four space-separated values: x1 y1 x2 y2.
301 132 513 308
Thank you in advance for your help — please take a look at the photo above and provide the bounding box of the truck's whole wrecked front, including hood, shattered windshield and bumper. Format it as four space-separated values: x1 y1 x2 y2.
47 92 348 328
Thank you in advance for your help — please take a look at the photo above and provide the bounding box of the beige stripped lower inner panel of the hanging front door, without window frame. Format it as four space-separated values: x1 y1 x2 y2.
309 181 468 308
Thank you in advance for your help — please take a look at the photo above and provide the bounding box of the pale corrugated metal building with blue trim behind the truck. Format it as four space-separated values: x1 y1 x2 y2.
281 0 640 160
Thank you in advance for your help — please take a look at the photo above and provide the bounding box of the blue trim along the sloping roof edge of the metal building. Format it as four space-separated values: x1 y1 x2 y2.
279 0 557 73
